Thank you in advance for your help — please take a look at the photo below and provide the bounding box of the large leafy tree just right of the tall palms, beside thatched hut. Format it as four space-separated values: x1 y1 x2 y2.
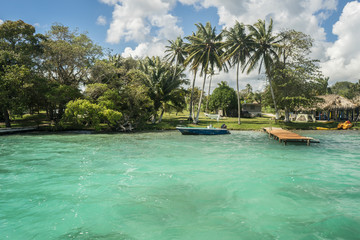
271 30 327 121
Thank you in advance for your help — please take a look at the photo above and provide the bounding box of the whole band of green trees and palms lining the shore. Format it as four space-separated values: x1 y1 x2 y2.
0 20 348 130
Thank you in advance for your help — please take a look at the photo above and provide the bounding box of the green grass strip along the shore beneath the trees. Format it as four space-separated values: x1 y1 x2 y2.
0 112 360 131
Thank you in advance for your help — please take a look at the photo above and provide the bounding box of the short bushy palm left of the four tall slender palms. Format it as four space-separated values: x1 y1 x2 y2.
140 57 188 123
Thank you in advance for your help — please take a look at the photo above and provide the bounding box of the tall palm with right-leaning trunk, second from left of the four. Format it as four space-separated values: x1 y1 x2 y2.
185 22 223 123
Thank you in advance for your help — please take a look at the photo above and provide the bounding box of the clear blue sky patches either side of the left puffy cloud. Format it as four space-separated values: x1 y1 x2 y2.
0 0 221 53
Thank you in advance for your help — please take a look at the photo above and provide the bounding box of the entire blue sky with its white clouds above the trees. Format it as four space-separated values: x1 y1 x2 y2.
0 0 360 87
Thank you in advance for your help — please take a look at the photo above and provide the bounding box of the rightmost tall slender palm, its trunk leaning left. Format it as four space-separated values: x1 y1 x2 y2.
247 19 280 119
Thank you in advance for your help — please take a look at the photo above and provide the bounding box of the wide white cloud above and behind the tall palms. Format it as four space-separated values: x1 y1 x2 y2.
179 0 337 89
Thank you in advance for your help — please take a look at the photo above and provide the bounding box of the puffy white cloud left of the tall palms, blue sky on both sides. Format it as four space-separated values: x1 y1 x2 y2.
101 0 183 57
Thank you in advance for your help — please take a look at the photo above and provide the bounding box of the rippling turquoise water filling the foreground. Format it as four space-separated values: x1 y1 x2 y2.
0 131 360 240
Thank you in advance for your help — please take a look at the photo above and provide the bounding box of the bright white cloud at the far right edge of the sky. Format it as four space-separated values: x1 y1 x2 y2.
322 1 360 83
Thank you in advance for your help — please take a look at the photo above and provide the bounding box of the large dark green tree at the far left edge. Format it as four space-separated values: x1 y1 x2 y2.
0 20 44 127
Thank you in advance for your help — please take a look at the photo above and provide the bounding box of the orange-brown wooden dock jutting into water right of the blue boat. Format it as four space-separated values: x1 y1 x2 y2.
264 128 319 146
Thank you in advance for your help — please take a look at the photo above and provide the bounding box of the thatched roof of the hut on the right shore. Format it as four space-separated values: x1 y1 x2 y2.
316 94 356 111
